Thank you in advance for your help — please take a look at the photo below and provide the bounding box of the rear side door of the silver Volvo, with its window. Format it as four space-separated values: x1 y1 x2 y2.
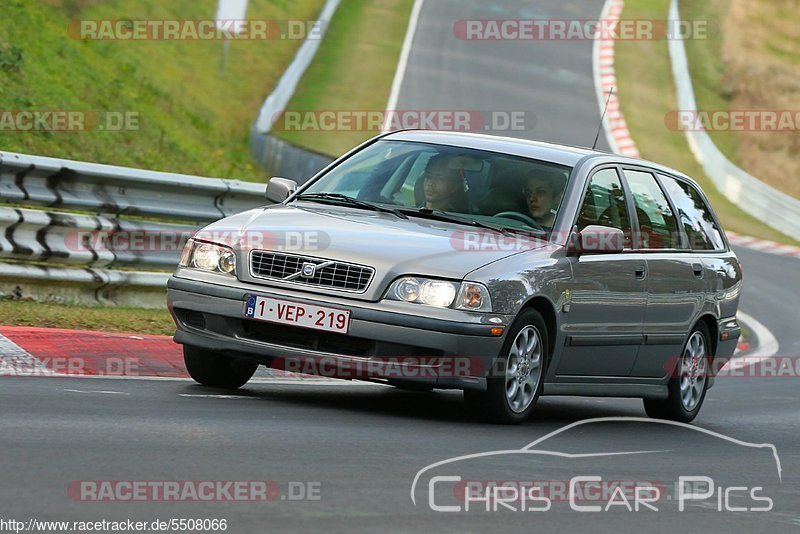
624 168 705 378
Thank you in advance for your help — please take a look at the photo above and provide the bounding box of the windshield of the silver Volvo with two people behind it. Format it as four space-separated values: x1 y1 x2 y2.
297 141 571 234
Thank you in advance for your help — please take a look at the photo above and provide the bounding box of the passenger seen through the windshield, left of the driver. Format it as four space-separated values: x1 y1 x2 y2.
422 154 469 213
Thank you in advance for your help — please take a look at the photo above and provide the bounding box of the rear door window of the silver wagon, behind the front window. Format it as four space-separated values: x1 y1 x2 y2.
625 169 684 249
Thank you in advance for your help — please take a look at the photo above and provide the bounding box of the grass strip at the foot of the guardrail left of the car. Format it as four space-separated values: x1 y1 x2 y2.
0 300 175 335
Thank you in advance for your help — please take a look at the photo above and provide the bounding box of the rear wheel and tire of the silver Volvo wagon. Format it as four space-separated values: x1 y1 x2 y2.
644 323 713 423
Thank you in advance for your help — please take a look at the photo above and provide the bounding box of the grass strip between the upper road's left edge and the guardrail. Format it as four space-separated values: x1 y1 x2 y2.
274 0 413 156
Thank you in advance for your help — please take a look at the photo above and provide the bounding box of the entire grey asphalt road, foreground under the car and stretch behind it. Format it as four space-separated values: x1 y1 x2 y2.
0 0 800 532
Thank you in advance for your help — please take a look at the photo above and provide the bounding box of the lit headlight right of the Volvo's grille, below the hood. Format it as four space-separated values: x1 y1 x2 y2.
386 276 492 311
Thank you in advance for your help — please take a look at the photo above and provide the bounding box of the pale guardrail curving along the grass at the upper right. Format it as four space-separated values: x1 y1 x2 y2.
669 0 800 240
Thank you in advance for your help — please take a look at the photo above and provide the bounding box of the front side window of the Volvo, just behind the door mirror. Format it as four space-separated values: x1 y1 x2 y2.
576 169 632 248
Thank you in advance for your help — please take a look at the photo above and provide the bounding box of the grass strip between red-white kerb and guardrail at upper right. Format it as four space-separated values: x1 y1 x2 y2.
616 0 798 244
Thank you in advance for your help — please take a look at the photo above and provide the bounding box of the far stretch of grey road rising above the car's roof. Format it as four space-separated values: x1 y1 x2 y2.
397 0 608 150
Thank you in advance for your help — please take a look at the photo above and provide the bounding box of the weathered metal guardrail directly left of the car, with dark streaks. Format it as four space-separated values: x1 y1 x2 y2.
0 152 267 298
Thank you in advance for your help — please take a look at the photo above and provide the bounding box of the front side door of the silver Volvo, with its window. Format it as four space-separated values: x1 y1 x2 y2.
557 167 647 380
